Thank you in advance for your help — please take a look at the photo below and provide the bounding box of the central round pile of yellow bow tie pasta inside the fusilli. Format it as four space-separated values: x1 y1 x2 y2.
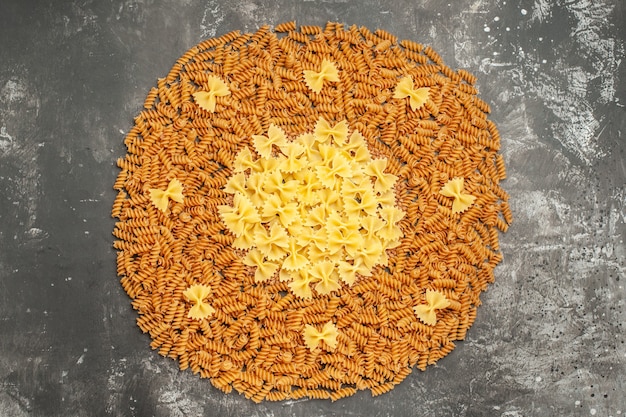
218 119 404 298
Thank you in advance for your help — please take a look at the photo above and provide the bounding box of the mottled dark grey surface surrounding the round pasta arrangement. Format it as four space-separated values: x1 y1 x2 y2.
0 0 626 417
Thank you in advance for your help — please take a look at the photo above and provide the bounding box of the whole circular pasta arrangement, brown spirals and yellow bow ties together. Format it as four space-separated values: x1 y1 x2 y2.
112 22 512 402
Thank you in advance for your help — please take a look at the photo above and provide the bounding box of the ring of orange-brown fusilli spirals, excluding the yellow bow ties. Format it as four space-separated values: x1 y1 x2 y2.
112 22 512 402
